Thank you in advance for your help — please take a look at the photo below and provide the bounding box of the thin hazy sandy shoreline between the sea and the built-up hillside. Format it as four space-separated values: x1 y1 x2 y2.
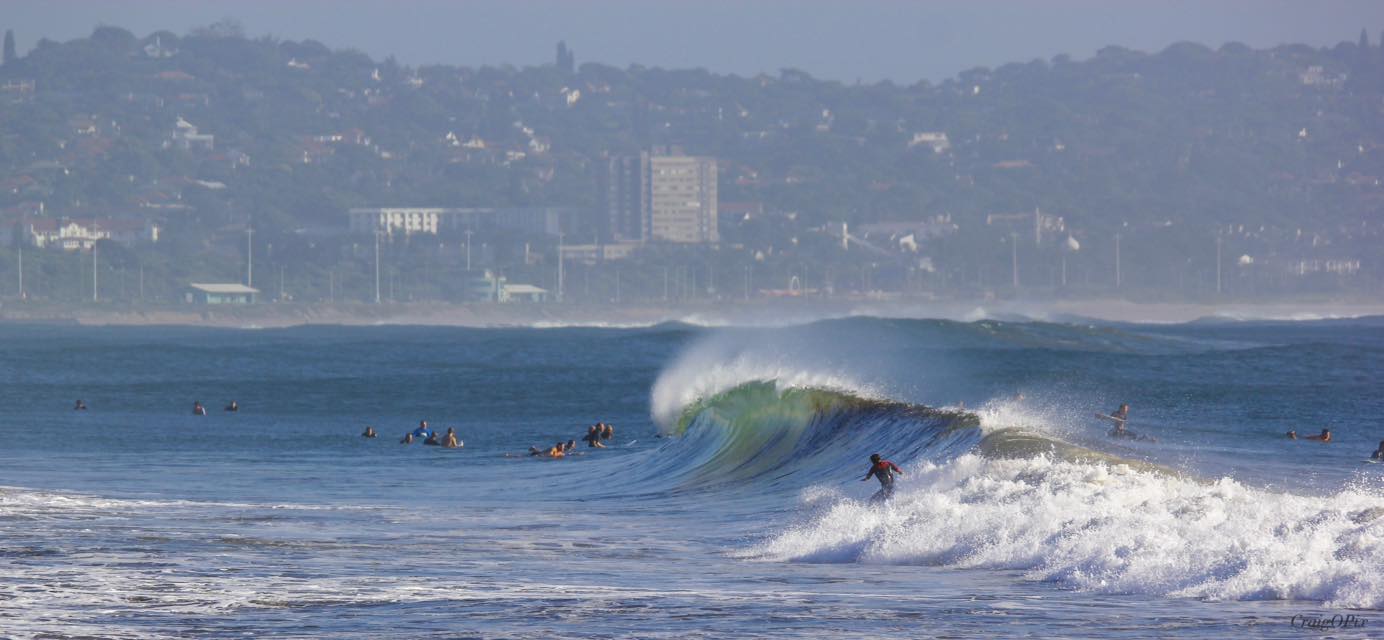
0 299 1384 328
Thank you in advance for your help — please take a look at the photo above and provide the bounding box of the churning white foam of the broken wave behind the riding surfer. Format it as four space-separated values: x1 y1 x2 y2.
746 454 1384 608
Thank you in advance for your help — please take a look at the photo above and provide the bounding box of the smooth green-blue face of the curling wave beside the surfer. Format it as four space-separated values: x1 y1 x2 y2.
645 381 1165 489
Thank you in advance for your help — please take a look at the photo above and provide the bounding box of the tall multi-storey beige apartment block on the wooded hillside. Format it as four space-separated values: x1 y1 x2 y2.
602 150 720 242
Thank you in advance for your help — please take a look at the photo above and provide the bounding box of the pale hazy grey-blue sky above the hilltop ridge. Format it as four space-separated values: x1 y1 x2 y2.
0 0 1384 83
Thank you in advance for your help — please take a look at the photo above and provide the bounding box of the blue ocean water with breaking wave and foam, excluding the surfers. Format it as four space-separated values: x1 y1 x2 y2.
0 317 1384 639
